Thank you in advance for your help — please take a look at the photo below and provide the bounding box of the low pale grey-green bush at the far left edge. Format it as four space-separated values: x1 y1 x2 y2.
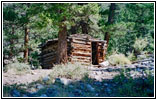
4 62 30 74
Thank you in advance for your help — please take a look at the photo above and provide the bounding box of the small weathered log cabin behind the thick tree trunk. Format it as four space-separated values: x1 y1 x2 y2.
40 34 106 69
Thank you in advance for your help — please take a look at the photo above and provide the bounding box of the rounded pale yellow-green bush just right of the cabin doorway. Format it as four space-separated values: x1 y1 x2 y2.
108 54 131 66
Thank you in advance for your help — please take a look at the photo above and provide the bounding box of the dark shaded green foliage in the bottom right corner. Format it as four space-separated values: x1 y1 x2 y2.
114 70 154 97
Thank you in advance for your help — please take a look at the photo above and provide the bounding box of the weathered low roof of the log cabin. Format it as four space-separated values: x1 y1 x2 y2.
39 34 106 48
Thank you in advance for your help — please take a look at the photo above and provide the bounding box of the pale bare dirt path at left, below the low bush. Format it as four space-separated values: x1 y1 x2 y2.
3 69 51 85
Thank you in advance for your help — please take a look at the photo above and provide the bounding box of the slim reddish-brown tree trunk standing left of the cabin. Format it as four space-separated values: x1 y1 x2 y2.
24 26 29 63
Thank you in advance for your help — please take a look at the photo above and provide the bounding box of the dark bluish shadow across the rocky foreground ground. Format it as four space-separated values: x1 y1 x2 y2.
3 74 154 97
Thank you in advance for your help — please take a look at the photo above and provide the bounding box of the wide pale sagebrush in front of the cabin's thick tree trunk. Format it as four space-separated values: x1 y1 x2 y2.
50 63 88 79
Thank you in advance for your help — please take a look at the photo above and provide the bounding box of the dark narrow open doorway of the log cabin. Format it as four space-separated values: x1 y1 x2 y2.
92 42 98 65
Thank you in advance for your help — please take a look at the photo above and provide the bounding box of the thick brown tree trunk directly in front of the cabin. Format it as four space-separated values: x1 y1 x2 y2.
56 23 67 64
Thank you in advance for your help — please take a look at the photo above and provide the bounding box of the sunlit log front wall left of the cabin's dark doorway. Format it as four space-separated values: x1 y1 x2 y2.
69 37 92 65
